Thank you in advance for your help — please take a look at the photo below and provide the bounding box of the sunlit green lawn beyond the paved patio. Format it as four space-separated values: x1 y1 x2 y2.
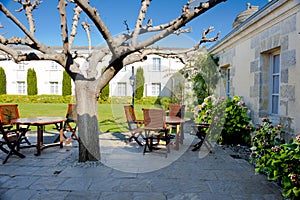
18 103 150 132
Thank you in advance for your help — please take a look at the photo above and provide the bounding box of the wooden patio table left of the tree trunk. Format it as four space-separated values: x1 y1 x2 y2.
11 117 66 156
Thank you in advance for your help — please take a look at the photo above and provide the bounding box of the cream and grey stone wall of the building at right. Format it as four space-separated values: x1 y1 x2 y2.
209 0 300 139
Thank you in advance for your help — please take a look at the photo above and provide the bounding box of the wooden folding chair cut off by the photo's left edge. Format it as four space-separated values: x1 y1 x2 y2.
0 104 33 164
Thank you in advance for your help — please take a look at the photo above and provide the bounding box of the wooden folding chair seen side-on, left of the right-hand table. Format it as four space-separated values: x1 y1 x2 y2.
124 105 144 146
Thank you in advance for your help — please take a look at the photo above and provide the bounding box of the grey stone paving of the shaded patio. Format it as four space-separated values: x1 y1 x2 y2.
0 130 283 200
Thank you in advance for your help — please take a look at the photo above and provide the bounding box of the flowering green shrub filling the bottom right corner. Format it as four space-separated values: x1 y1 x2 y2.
251 118 300 200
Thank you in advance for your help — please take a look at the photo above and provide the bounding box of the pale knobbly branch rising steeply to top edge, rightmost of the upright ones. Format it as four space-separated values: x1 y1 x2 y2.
132 0 151 47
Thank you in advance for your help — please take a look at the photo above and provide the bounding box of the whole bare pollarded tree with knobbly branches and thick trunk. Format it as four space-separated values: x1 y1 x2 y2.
0 0 225 162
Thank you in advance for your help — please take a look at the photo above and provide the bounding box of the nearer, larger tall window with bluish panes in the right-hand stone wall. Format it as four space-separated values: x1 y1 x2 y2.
270 54 280 114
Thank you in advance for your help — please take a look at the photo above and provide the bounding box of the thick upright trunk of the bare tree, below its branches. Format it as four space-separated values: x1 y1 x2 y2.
75 80 100 162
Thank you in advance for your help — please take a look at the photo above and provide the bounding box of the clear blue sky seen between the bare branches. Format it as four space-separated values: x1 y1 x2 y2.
0 0 268 46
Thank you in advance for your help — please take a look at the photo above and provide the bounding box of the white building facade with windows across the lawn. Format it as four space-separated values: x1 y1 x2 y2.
0 47 184 97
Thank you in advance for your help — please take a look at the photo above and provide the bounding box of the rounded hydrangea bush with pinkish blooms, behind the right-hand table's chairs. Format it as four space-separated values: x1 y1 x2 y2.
195 96 253 145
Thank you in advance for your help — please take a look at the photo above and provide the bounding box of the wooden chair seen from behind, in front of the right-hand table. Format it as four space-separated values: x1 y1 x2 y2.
143 108 170 154
